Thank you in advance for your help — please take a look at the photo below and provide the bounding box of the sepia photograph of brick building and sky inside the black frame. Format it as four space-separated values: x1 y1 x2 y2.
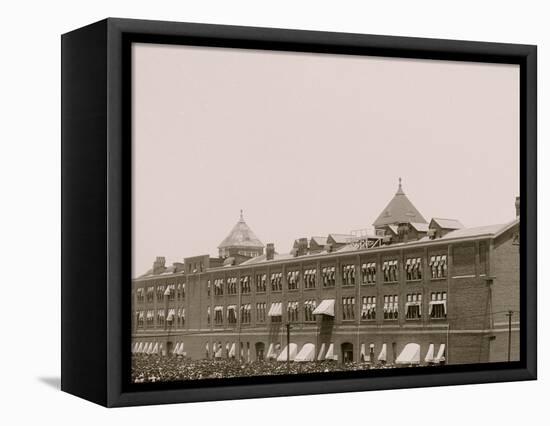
129 42 520 383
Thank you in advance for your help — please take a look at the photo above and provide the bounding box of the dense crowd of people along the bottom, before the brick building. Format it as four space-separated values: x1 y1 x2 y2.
132 355 394 383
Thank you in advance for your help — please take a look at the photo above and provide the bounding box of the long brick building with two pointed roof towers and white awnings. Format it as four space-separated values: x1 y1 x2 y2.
132 182 520 365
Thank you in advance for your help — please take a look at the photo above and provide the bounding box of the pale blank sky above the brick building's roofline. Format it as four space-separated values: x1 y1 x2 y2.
132 44 519 276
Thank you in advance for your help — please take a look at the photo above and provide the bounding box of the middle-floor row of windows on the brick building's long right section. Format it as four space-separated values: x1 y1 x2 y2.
207 292 447 325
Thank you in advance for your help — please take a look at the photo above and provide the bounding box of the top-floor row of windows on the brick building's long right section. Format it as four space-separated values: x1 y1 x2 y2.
207 255 447 296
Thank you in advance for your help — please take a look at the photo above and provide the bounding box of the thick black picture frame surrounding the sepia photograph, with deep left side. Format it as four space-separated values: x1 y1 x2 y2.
61 18 537 407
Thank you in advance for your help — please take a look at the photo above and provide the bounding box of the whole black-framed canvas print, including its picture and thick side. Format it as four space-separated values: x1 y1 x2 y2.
61 18 537 407
